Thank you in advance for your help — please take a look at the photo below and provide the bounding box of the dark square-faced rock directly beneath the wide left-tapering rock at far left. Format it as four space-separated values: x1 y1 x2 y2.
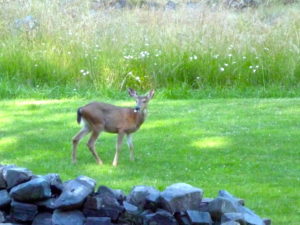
11 201 38 222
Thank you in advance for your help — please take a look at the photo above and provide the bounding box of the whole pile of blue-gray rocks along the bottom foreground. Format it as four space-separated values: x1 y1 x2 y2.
0 165 271 225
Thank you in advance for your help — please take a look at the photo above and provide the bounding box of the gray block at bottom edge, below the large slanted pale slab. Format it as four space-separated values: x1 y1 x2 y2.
52 209 85 225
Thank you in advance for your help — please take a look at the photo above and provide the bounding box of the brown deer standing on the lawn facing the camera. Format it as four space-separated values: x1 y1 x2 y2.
72 88 154 167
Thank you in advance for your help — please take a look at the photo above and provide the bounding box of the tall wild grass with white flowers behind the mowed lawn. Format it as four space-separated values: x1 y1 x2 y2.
0 0 300 97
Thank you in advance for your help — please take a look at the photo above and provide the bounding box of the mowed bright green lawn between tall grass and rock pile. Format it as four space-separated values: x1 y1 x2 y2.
0 98 300 225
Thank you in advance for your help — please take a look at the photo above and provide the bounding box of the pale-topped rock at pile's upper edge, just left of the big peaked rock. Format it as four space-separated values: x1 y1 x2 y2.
127 185 160 210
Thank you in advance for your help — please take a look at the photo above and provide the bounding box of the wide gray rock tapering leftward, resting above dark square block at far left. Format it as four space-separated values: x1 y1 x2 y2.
9 178 51 202
